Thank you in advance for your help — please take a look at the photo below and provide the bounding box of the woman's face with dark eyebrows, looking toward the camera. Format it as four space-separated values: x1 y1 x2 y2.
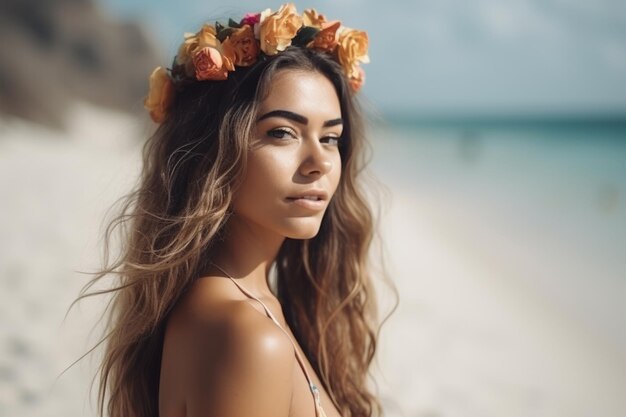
232 70 343 239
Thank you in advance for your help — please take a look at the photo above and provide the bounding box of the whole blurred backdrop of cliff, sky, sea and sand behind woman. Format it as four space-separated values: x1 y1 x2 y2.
0 0 626 417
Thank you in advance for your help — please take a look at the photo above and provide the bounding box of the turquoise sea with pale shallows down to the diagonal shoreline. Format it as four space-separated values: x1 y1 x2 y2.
372 119 626 351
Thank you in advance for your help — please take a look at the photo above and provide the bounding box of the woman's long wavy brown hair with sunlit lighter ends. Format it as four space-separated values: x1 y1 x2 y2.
78 47 390 417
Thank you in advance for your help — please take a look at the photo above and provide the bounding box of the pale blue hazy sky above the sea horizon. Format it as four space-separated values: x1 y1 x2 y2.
98 0 626 116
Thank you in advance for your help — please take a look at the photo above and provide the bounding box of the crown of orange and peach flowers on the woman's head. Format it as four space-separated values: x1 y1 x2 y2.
144 3 369 123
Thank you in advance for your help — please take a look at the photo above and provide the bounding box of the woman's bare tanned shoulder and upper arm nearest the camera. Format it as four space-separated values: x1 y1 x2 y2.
159 278 294 417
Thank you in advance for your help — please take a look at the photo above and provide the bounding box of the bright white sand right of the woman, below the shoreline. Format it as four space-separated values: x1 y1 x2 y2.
370 190 626 416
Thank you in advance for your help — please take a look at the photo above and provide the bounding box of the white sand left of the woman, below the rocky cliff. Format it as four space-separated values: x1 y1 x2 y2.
0 106 139 417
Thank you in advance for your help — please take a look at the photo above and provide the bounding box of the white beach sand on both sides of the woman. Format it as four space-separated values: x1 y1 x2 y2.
0 105 626 417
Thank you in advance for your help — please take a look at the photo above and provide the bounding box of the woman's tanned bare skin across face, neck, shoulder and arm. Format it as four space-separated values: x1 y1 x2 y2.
159 70 342 417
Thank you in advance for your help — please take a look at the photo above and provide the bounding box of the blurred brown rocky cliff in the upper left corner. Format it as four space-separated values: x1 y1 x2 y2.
0 0 158 127
